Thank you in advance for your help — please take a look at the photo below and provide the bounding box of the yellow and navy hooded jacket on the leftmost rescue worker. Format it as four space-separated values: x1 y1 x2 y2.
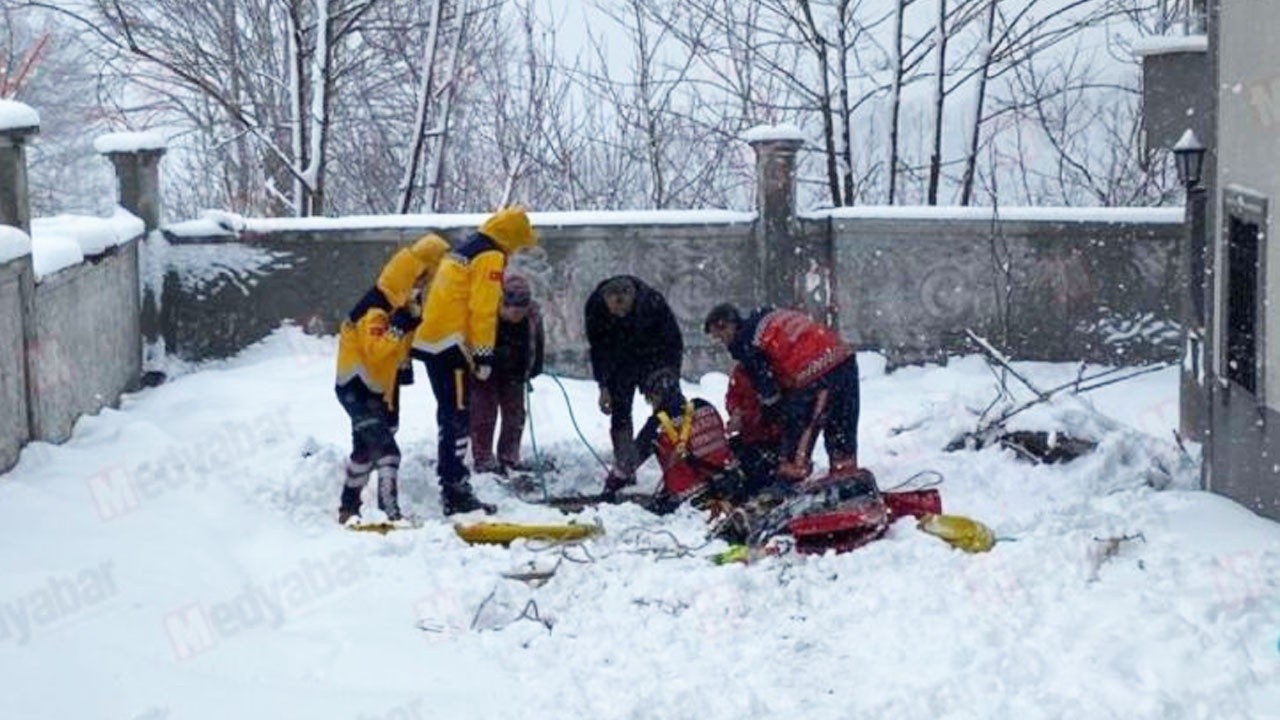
337 234 449 410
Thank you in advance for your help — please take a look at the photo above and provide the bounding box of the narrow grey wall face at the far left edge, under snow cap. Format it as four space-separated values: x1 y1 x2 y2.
0 255 32 471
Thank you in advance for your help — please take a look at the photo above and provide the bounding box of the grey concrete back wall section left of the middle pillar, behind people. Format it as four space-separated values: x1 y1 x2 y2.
157 223 759 374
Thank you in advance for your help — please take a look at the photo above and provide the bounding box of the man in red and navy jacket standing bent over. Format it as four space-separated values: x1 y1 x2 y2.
703 302 859 482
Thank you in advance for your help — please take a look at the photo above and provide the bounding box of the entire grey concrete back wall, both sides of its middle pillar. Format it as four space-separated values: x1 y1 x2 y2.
159 211 1183 375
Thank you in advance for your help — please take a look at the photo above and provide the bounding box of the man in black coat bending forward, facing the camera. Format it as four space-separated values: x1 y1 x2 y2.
585 275 685 492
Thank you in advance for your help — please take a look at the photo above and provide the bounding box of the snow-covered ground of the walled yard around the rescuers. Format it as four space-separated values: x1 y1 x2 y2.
0 329 1280 720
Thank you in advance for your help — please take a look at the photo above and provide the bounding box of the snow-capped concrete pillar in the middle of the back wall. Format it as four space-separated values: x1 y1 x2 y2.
742 126 804 307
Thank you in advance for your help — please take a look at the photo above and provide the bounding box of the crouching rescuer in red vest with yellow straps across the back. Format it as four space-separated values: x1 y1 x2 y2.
611 369 744 514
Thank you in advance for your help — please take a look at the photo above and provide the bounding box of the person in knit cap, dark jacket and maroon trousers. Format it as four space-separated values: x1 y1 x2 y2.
471 274 545 475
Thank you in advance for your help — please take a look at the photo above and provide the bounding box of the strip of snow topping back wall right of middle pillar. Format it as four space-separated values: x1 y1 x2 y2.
800 205 1184 224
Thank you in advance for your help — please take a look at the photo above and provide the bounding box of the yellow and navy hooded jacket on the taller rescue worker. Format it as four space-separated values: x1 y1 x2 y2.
413 206 538 365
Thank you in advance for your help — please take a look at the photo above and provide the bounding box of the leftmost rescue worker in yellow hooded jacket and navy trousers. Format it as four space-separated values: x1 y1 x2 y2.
335 234 449 523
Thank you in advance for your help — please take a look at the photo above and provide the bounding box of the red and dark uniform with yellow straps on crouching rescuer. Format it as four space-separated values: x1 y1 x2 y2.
636 396 739 509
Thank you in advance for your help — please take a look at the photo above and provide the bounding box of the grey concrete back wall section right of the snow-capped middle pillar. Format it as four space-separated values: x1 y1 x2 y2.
832 210 1184 364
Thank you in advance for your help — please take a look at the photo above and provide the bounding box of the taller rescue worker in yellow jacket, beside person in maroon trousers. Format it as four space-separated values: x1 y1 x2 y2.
412 206 538 515
